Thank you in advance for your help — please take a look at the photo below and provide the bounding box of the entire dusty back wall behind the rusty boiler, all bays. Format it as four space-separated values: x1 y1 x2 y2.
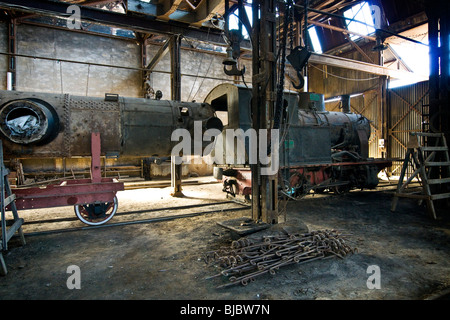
0 22 237 176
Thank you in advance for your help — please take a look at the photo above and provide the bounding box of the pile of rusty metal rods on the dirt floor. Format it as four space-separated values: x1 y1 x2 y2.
206 230 357 288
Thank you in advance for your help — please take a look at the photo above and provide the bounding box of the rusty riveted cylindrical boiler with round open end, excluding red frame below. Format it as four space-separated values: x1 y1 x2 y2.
0 91 223 158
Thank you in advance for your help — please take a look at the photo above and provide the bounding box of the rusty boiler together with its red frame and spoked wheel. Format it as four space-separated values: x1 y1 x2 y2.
0 91 222 225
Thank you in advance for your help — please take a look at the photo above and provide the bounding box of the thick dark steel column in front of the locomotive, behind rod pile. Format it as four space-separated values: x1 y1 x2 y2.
251 0 278 223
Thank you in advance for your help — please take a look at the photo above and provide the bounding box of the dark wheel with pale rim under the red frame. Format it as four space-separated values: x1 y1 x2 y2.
74 196 118 226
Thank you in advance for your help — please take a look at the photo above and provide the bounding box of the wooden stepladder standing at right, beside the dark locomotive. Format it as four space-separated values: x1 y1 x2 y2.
391 132 450 219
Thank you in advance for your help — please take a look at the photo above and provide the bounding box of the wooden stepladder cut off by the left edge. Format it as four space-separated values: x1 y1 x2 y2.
0 140 26 275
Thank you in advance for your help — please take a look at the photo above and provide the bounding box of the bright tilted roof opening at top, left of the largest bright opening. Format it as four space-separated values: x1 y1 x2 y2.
344 1 375 41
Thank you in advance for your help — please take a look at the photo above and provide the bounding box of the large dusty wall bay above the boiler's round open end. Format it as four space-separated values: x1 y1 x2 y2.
16 25 141 97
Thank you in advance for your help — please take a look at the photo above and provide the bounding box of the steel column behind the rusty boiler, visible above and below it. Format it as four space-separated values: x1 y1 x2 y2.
170 35 183 197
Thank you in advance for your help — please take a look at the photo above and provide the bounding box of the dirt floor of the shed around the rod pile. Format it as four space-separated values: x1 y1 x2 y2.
0 176 450 300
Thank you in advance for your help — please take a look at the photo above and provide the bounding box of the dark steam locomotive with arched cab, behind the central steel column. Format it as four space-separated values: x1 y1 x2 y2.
205 84 392 198
